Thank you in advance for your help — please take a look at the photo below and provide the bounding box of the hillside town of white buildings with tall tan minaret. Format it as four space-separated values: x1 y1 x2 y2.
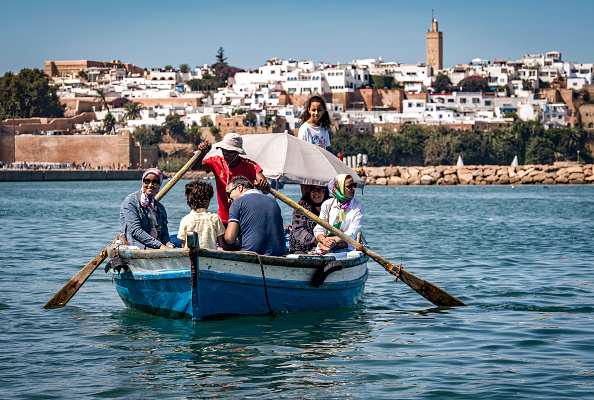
0 19 594 173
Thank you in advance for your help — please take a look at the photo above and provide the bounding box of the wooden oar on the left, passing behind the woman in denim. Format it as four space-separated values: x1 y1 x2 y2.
43 151 202 308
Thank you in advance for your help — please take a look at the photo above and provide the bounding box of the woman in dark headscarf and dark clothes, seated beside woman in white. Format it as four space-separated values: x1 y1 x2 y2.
289 185 329 254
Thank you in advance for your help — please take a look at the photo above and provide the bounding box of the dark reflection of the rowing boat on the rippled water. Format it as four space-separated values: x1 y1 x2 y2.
96 307 372 396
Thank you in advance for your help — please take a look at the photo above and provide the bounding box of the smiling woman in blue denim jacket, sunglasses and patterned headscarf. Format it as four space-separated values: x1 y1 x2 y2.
120 168 175 249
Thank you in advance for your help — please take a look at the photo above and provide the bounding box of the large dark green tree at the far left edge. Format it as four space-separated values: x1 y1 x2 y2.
0 68 65 118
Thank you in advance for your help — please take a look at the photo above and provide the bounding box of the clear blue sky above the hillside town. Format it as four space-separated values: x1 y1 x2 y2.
0 0 594 74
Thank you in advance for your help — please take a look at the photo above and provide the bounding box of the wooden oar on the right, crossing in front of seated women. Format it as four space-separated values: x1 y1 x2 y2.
270 189 466 307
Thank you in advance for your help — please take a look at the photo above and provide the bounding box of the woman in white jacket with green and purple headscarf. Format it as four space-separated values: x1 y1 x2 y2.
314 174 364 253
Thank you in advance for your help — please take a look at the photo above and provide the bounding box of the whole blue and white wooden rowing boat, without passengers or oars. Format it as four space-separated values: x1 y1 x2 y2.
108 245 369 319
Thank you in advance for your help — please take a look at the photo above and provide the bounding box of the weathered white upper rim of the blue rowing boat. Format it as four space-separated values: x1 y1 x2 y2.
108 245 369 268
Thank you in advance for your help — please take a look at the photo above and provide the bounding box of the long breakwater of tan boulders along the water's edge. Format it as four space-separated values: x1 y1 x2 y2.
365 163 594 186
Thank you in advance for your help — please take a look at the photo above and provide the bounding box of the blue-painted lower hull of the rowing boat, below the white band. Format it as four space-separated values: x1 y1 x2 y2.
114 270 367 319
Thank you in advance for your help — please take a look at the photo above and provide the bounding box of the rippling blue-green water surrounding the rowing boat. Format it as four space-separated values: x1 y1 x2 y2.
0 181 594 399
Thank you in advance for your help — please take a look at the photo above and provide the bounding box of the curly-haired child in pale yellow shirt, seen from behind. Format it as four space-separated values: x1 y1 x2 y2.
177 180 232 250
